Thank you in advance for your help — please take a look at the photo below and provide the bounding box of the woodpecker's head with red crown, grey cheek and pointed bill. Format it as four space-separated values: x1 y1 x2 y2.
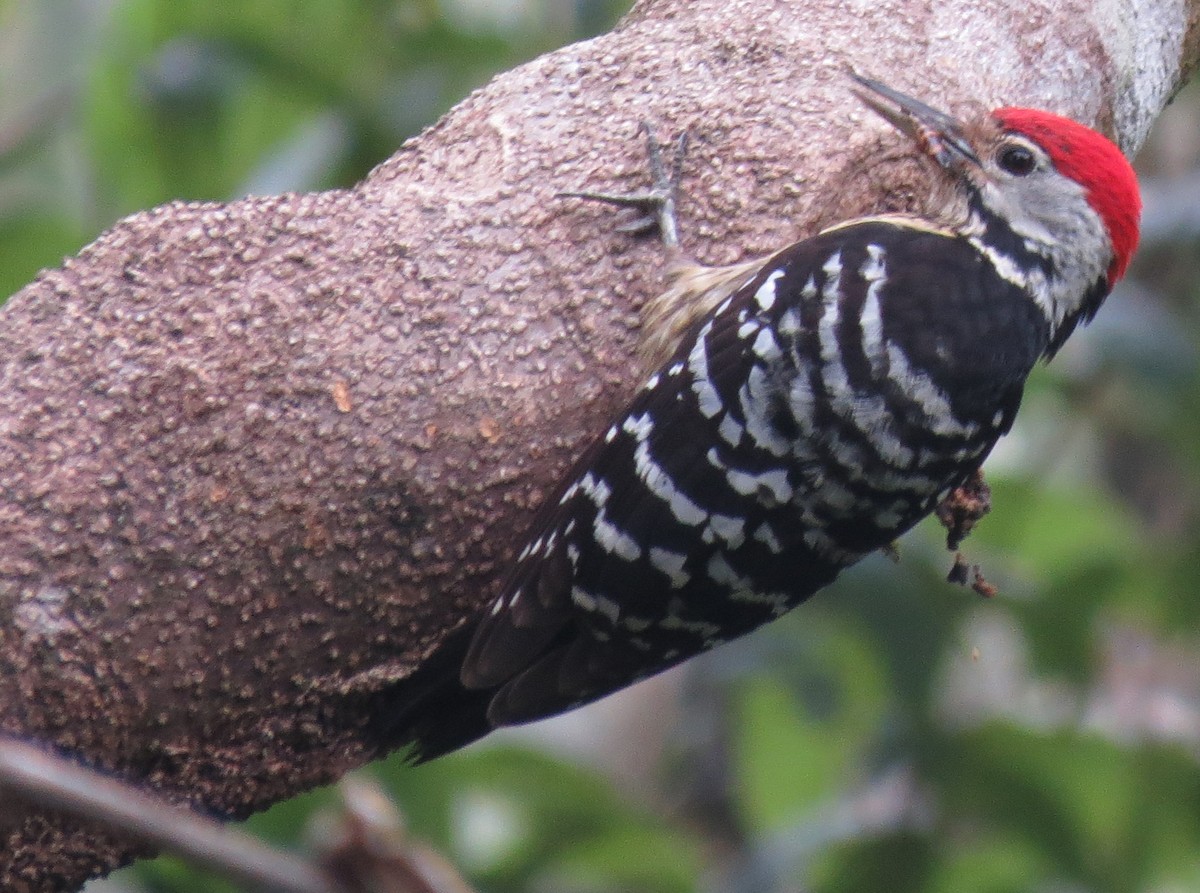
854 76 1141 353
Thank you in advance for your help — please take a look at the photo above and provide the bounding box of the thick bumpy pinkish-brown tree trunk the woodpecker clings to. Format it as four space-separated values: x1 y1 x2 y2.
0 0 1196 891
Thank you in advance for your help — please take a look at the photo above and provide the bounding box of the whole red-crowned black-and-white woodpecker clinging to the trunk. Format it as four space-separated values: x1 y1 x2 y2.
390 76 1141 761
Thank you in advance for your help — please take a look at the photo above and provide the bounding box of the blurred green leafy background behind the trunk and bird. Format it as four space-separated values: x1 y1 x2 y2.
0 0 1200 893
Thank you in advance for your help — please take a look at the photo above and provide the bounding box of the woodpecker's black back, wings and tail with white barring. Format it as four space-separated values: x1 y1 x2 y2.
392 218 1049 759
